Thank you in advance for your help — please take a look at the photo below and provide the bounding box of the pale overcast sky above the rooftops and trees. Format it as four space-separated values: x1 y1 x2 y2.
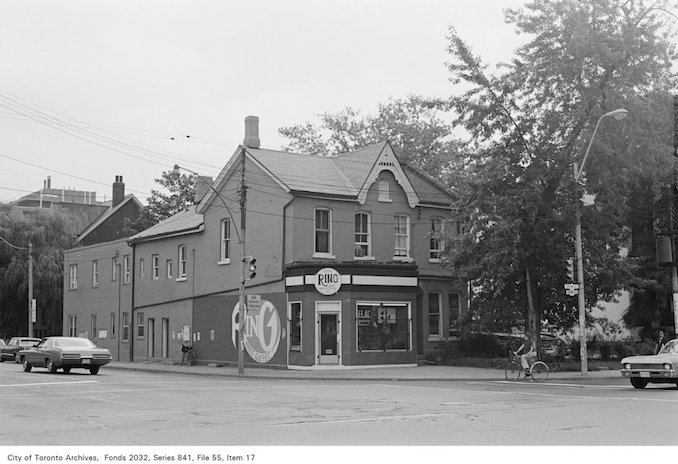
0 0 526 203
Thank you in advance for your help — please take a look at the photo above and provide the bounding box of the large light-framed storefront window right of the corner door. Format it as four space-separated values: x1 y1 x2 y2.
356 303 410 351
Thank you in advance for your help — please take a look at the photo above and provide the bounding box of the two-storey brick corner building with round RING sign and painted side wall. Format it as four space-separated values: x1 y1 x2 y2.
64 117 468 369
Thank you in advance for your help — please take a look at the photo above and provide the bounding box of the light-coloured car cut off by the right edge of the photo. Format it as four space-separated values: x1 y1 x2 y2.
621 339 678 388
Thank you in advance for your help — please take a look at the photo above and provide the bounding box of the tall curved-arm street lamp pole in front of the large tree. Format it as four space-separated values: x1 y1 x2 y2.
573 108 628 376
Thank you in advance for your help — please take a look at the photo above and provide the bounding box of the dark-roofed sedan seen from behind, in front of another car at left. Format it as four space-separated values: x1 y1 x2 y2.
17 337 111 374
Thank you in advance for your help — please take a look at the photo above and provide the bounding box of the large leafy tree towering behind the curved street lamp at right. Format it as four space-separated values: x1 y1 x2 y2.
443 0 677 340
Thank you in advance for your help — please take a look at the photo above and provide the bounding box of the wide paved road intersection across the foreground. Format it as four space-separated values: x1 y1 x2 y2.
0 363 678 447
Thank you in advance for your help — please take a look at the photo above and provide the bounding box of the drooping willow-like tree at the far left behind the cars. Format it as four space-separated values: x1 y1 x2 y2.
0 205 74 338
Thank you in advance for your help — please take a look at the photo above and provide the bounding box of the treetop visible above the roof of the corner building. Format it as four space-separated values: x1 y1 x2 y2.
279 95 460 180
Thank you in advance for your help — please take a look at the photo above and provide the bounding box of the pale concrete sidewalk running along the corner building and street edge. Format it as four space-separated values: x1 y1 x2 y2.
104 361 622 382
